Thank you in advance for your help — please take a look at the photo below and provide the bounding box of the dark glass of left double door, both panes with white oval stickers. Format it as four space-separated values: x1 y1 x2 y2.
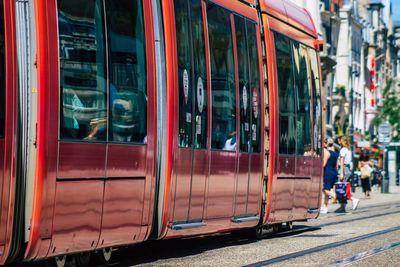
174 0 207 149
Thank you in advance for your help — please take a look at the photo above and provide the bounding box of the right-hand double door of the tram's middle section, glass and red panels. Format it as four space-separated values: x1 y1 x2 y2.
234 16 261 219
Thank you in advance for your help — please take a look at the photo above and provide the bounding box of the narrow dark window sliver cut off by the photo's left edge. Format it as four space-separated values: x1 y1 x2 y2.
0 1 6 138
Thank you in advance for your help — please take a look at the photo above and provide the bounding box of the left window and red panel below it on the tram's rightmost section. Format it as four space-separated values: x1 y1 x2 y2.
272 32 296 220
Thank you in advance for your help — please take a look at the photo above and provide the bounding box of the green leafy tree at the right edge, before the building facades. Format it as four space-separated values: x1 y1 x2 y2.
372 79 400 142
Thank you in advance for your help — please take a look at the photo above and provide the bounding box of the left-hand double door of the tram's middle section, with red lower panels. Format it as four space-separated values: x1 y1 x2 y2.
173 0 209 224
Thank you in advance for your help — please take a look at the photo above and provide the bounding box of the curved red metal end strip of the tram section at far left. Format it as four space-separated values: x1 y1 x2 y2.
0 1 17 264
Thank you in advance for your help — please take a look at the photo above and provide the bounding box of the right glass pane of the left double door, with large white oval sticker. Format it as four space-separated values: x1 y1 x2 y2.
190 0 208 149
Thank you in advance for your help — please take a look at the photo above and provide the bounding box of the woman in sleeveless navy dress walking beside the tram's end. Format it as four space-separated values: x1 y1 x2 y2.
320 138 338 213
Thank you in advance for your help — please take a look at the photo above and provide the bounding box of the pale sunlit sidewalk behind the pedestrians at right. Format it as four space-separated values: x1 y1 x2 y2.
328 186 400 213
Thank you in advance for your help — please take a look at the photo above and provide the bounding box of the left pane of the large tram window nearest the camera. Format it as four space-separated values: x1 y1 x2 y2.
57 0 107 141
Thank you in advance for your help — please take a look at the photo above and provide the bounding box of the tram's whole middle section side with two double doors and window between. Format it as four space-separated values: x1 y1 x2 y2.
163 0 263 238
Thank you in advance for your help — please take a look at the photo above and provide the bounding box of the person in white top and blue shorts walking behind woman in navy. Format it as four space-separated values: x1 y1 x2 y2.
335 136 360 212
